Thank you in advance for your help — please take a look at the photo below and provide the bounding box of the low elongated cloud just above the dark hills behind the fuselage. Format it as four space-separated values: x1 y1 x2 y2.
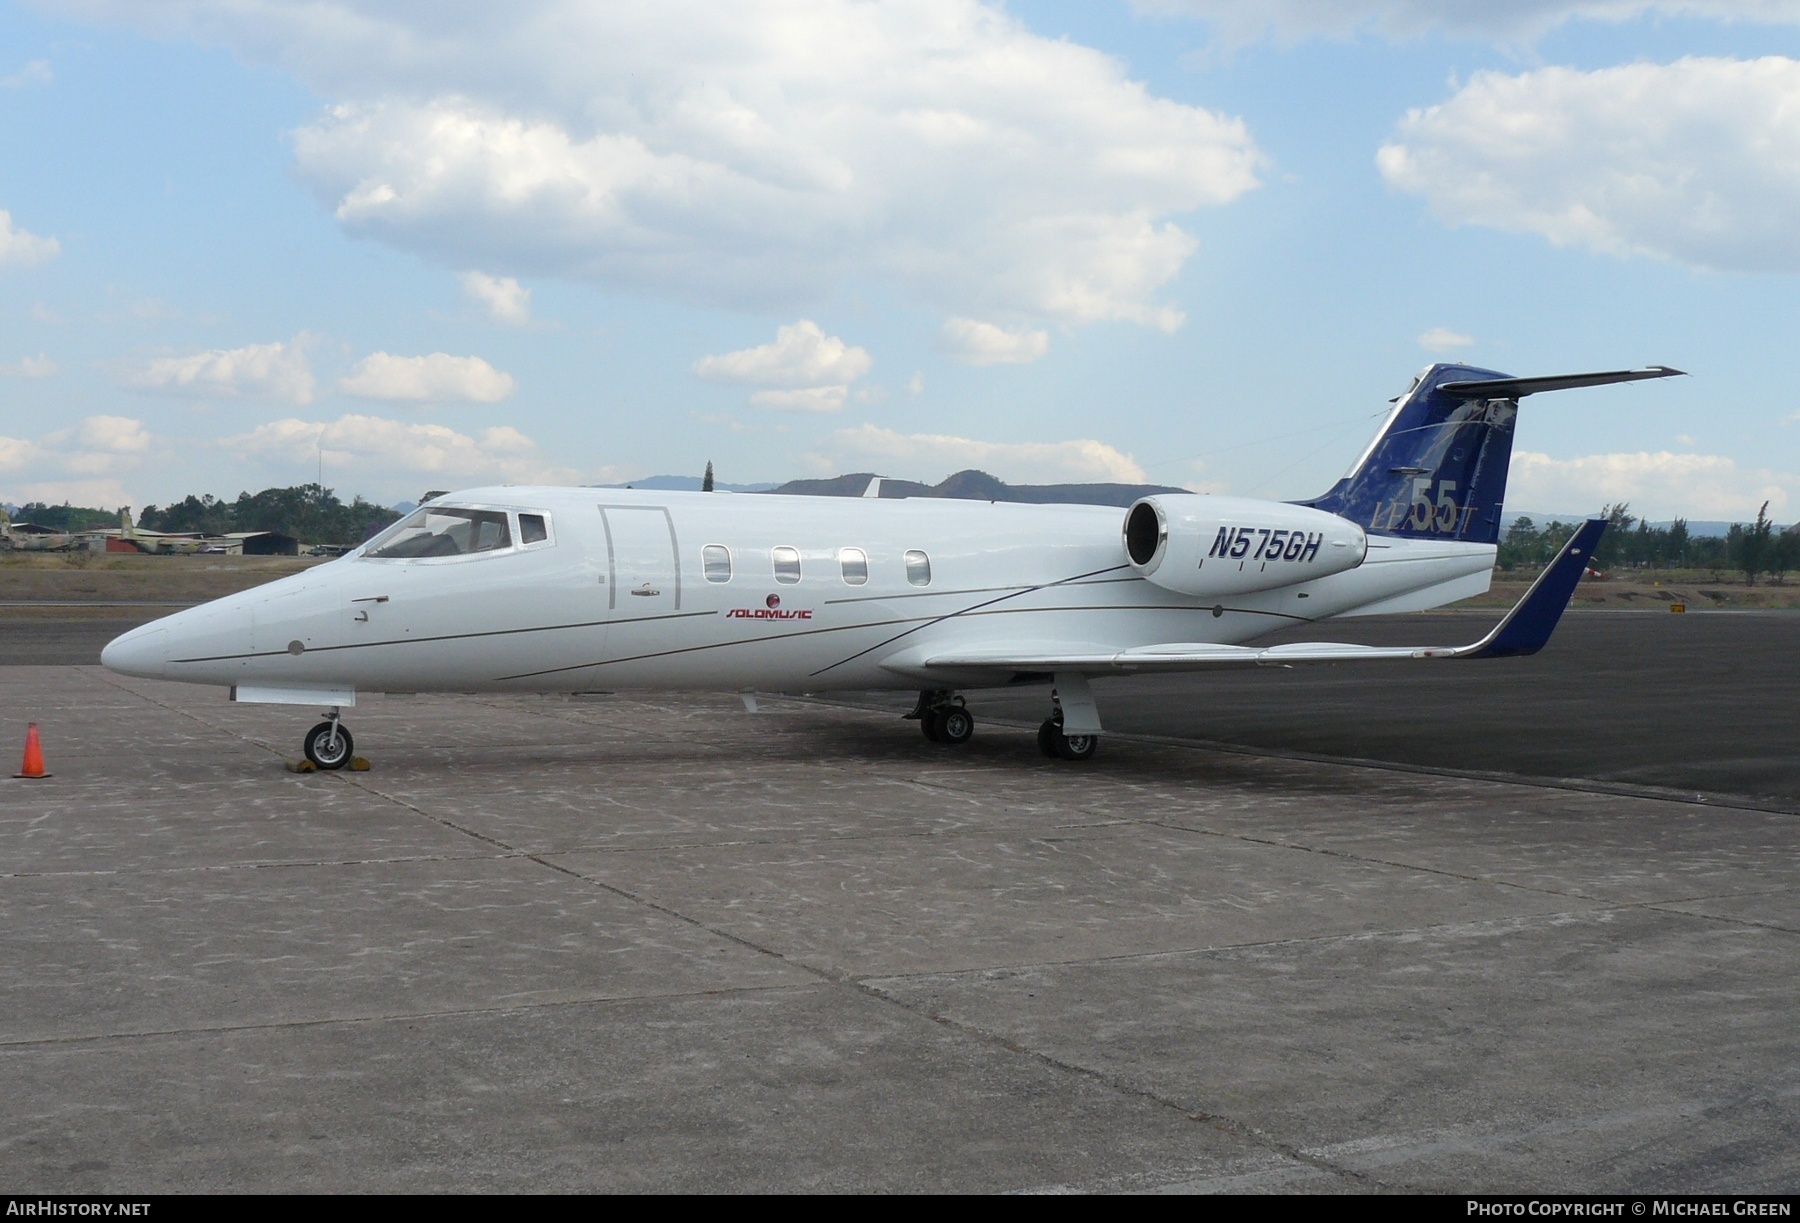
824 425 1145 485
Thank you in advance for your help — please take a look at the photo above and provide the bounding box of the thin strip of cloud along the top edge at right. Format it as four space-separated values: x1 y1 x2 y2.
1130 0 1800 45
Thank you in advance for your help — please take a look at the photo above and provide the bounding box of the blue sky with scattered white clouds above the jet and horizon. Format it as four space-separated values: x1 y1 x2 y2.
0 0 1800 521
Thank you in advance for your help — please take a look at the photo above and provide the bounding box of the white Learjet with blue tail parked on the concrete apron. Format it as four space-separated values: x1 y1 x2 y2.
101 364 1679 769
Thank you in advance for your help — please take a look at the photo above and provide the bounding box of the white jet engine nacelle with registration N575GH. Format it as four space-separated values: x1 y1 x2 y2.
1125 494 1368 598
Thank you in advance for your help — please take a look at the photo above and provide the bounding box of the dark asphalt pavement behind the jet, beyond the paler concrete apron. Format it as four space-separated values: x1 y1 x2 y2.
21 607 1800 799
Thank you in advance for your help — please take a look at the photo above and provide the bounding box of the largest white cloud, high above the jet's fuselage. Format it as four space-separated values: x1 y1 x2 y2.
59 0 1262 326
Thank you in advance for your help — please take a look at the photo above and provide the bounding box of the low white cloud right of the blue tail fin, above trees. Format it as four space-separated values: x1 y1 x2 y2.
1507 450 1795 521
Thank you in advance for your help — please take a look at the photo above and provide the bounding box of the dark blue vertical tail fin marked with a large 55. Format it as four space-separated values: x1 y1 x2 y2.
1303 366 1519 544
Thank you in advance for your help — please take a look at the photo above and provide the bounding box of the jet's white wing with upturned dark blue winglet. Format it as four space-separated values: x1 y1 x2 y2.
905 519 1606 675
